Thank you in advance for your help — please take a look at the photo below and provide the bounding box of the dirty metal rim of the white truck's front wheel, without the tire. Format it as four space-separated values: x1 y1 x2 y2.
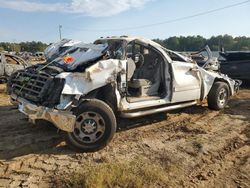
73 112 105 144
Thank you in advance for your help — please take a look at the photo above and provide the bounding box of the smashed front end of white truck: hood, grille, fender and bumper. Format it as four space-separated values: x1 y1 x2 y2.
7 38 121 132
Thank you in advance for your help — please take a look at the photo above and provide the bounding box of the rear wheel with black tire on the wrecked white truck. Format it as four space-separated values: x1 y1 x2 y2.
207 82 230 110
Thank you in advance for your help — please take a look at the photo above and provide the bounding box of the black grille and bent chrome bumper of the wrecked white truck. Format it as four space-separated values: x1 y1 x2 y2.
7 65 75 131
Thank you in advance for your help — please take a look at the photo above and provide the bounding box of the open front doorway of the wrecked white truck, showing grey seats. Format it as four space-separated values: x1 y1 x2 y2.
126 41 166 103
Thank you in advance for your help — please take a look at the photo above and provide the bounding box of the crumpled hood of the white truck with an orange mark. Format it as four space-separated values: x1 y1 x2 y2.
45 39 108 71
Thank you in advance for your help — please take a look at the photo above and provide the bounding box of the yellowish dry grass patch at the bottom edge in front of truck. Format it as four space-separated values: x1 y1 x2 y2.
55 159 168 188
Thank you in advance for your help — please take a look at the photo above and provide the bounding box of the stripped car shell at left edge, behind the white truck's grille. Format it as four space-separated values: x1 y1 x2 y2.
0 53 29 81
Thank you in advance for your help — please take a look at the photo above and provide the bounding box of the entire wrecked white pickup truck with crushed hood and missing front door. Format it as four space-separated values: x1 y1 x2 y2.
8 36 240 151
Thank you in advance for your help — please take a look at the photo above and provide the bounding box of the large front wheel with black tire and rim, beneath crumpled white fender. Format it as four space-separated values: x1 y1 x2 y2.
64 99 117 152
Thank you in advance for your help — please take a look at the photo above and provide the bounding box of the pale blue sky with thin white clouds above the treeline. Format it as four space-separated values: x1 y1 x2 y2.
0 0 250 43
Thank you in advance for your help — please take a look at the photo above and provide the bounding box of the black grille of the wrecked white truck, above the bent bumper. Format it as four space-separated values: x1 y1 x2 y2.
9 70 53 103
